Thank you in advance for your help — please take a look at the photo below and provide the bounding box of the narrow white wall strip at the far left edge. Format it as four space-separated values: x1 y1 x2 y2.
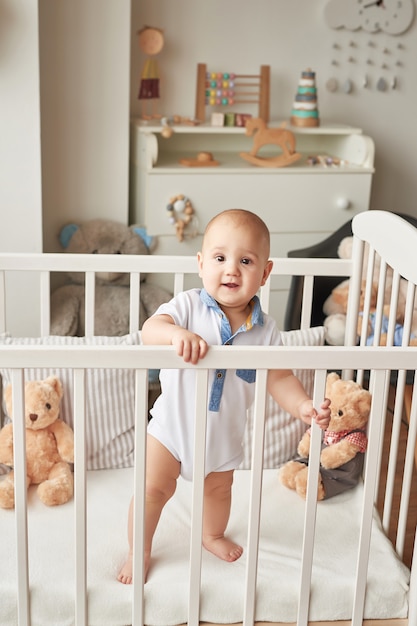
0 0 42 252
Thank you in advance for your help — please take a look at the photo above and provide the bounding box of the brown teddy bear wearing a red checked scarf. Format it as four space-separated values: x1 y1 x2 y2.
280 372 372 500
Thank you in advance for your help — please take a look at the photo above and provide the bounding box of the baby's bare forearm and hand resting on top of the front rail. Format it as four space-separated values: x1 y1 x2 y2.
142 315 208 364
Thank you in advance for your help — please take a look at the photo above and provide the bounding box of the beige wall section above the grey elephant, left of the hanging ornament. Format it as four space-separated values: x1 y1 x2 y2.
39 0 130 252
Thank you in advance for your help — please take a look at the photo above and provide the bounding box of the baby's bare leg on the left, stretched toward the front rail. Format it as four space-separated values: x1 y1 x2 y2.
117 435 180 584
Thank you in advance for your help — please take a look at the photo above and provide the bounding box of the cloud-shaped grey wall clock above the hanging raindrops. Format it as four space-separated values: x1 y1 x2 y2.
324 0 414 35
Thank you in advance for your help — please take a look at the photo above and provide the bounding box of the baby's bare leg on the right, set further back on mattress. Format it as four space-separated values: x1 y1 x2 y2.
203 470 243 561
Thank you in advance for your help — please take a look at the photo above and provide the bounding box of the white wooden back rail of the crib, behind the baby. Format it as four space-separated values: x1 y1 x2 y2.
0 253 352 336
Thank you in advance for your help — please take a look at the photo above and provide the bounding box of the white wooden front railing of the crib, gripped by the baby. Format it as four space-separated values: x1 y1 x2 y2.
0 346 417 626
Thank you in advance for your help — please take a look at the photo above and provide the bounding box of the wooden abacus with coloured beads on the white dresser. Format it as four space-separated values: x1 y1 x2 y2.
195 63 270 123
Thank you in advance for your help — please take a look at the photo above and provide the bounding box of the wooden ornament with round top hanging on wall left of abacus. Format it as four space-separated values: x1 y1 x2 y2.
138 26 164 119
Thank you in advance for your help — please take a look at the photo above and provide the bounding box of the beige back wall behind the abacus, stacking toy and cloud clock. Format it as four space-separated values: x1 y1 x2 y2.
131 0 417 216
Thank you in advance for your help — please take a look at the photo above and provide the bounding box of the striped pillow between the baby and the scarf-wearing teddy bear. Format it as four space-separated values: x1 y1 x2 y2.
240 326 324 469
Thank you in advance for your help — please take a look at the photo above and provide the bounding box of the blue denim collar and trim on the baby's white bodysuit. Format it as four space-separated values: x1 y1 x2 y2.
200 289 264 412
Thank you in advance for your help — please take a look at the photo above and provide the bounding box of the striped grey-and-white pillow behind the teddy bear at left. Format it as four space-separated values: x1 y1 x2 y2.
0 332 140 469
